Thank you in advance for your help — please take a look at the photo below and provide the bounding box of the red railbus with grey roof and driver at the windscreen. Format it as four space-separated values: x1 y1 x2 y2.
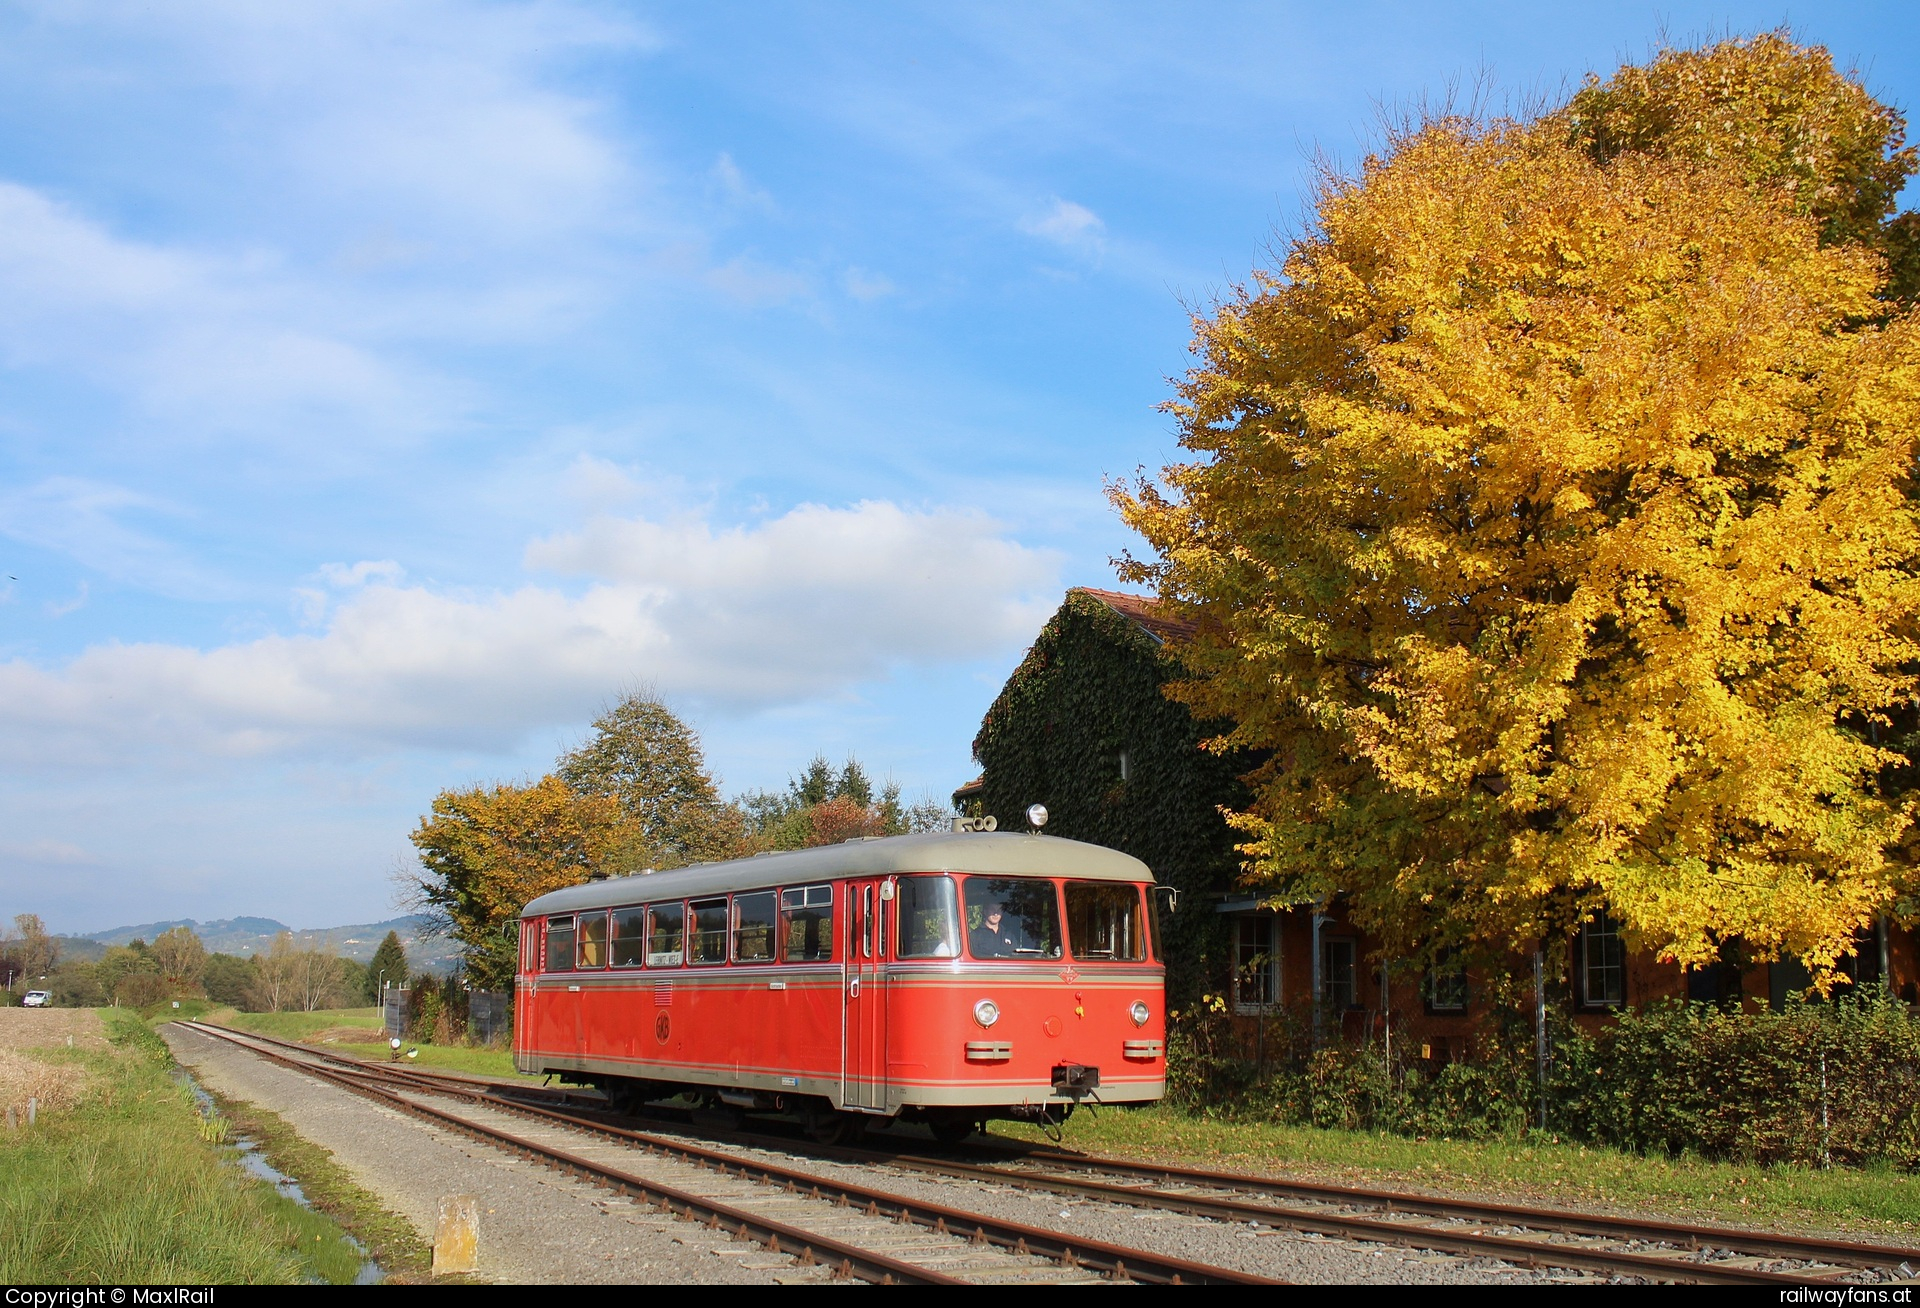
513 832 1165 1139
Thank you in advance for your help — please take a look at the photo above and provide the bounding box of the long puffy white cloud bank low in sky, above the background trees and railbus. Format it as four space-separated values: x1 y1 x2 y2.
0 501 1058 766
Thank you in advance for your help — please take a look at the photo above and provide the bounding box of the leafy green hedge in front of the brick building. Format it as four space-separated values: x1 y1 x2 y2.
1167 999 1920 1170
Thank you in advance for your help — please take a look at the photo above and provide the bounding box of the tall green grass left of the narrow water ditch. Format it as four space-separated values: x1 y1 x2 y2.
0 1008 361 1285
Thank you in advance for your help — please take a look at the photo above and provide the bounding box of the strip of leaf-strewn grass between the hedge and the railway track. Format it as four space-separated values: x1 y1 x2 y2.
993 1106 1920 1243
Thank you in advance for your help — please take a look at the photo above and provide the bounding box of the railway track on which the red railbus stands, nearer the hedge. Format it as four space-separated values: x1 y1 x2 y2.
187 1037 1920 1285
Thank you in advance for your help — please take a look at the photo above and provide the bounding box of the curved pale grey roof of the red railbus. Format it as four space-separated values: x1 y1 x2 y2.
520 832 1154 918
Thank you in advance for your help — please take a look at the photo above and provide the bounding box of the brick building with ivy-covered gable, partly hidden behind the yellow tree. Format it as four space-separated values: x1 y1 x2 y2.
954 588 1920 1062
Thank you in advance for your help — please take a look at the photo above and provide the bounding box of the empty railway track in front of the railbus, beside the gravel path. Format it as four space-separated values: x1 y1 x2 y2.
179 1022 1279 1285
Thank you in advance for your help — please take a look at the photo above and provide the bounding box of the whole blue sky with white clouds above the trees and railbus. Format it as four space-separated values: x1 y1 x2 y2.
0 0 1920 932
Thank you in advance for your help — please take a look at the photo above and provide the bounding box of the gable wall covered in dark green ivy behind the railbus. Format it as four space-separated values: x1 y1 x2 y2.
973 590 1246 1003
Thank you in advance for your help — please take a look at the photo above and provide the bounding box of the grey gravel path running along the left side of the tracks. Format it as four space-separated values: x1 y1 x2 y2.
159 1026 793 1285
